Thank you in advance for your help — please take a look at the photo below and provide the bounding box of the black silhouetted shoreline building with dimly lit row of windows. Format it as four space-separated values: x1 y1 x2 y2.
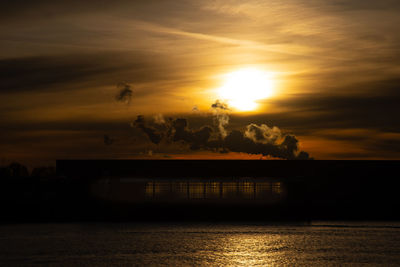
0 160 400 223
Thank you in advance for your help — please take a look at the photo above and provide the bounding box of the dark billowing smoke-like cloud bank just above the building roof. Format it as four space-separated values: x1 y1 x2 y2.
135 116 310 159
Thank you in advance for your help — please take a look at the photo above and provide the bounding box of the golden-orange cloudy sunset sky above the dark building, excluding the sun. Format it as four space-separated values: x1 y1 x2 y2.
0 0 400 165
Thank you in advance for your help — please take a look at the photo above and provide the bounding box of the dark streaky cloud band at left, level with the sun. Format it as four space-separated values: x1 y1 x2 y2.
0 51 175 93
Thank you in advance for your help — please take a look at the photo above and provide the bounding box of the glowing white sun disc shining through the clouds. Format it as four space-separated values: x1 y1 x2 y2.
218 68 274 111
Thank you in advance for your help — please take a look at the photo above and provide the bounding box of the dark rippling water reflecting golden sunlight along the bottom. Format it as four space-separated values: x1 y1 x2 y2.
0 222 400 266
